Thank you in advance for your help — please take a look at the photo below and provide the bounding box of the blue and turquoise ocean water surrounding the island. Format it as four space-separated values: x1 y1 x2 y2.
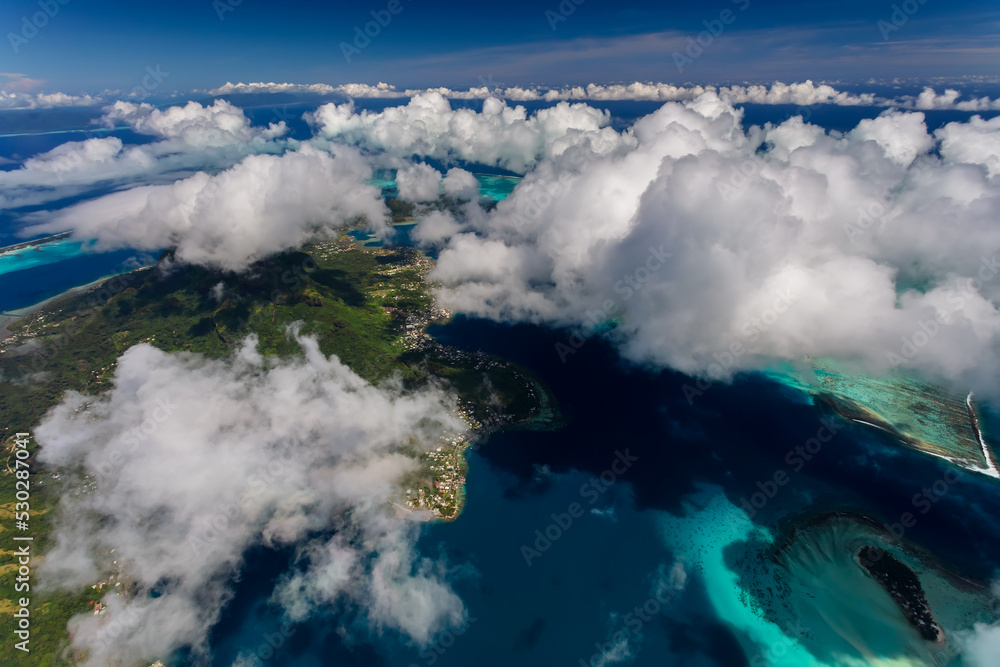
0 103 1000 667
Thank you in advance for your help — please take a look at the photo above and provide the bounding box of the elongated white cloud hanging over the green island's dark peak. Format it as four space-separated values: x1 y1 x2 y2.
28 145 387 270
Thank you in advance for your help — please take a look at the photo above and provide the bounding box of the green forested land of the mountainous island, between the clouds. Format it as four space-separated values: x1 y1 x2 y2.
0 237 552 665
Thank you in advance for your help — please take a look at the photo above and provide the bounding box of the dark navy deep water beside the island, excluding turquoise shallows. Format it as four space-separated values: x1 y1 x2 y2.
201 318 1000 667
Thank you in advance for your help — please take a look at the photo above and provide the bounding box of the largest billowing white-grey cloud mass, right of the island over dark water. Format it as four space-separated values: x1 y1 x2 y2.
418 93 1000 393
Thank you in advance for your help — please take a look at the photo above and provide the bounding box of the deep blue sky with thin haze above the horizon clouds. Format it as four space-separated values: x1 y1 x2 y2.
0 0 1000 93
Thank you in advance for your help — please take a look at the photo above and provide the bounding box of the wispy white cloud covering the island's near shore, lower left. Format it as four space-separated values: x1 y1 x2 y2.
36 337 465 665
